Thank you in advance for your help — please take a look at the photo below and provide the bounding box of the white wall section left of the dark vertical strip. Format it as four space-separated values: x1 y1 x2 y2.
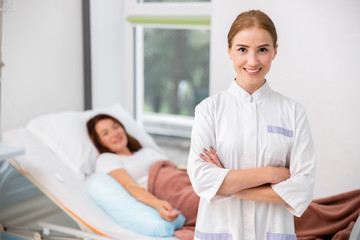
0 0 84 131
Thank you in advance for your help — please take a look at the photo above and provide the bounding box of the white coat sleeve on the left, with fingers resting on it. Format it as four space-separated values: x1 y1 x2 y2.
187 99 229 203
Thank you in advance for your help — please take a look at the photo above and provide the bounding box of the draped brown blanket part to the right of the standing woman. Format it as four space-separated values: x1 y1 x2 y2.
295 189 360 240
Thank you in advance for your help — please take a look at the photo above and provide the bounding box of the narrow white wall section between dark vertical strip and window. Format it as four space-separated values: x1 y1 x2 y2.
90 0 127 108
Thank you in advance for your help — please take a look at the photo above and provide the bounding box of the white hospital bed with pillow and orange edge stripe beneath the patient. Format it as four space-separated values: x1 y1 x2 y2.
0 105 177 240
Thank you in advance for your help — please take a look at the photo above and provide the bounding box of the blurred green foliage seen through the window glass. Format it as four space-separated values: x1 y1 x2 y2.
144 28 210 116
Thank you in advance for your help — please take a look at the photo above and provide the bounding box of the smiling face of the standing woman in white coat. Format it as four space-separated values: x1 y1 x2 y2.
228 27 277 94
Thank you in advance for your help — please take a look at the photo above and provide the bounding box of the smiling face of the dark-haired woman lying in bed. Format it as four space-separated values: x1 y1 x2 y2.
95 119 131 155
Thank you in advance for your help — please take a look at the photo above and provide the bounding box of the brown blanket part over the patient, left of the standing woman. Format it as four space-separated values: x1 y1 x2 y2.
148 161 200 240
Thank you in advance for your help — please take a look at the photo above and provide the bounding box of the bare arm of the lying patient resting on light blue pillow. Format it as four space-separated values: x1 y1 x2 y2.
109 169 181 221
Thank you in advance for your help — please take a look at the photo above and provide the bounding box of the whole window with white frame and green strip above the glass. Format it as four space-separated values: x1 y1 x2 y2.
124 1 210 137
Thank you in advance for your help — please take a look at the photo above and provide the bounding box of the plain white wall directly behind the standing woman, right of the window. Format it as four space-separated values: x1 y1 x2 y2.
211 0 360 198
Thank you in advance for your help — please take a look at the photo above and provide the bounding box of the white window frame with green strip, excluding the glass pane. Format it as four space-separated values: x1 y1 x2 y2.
124 0 211 138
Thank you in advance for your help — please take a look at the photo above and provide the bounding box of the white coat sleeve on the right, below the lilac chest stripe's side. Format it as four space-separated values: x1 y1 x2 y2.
272 105 316 217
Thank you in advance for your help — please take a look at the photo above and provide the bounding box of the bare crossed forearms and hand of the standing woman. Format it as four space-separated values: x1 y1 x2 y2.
200 147 290 204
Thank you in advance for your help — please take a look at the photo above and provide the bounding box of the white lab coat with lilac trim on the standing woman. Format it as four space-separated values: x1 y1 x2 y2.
188 81 316 240
